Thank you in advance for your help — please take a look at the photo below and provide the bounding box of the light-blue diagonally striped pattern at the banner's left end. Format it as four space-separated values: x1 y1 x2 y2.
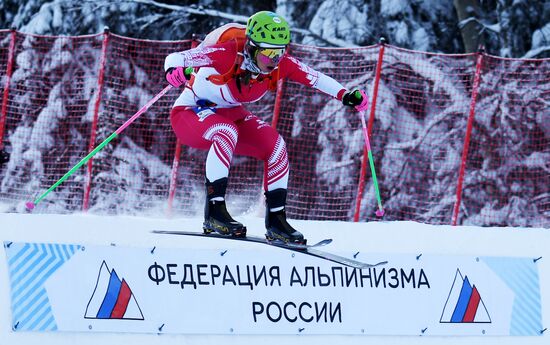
4 243 81 331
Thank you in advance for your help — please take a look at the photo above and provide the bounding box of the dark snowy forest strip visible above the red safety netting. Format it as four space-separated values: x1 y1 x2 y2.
0 0 550 58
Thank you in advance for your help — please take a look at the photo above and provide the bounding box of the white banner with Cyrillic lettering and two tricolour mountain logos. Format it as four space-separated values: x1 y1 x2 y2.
4 242 542 336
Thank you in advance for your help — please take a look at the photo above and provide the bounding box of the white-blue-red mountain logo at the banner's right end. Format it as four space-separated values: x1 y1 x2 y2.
439 269 491 323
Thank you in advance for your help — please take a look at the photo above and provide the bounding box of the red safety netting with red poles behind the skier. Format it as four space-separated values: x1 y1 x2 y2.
0 30 550 227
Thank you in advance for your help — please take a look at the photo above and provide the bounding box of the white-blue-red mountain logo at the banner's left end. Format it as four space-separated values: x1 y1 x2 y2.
84 261 144 320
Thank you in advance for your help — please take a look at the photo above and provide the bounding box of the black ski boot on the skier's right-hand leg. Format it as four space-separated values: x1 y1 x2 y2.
265 188 306 244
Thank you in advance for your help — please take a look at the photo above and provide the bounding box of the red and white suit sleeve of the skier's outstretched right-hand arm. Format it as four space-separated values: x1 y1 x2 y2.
279 56 347 100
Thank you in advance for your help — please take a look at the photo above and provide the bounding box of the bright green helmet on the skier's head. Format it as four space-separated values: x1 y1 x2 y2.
246 11 290 47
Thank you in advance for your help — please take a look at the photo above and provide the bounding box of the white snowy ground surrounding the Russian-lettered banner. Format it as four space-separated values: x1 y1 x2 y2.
0 213 550 345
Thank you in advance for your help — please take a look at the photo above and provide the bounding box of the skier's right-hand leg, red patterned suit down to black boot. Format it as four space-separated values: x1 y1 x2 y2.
235 114 306 243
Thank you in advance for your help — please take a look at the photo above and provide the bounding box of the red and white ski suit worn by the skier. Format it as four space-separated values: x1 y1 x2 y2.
164 41 347 191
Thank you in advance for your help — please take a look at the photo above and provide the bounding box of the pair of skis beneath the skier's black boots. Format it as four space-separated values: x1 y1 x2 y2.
152 230 388 269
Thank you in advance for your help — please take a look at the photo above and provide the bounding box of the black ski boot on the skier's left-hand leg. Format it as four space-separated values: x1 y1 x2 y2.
202 178 246 237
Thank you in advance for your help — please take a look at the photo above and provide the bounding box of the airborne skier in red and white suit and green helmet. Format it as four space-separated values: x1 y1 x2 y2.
164 11 367 244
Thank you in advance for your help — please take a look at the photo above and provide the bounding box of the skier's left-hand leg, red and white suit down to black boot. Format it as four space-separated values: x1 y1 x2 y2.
170 107 246 236
